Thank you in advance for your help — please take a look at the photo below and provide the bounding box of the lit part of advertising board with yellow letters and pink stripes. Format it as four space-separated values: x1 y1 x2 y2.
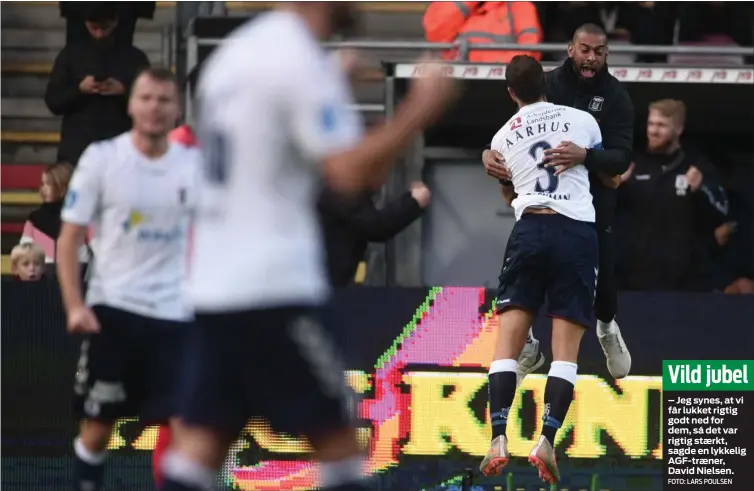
104 288 662 491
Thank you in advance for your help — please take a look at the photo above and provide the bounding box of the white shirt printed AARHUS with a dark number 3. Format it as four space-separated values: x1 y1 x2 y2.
491 102 602 222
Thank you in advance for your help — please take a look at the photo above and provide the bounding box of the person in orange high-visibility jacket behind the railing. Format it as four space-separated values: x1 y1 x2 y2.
424 2 542 63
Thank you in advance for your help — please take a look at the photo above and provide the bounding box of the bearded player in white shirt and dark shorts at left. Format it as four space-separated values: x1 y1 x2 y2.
57 69 200 491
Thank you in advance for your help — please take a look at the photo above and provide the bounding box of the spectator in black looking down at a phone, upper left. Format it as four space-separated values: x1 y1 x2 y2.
45 2 149 165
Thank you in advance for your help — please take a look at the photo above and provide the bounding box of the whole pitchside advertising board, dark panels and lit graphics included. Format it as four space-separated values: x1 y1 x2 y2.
2 281 754 490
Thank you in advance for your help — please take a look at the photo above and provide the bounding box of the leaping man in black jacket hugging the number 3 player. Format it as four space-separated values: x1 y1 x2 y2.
482 24 634 378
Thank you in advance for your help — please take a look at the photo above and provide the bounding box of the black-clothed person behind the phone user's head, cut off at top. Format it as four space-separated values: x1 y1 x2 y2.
59 2 157 47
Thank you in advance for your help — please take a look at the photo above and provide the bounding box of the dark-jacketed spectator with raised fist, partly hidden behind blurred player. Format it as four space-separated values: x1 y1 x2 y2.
318 182 431 287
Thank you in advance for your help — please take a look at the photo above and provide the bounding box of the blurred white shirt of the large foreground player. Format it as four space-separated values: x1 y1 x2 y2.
189 12 363 312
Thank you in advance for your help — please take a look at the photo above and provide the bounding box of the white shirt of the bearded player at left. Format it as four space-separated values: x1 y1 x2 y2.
62 132 200 321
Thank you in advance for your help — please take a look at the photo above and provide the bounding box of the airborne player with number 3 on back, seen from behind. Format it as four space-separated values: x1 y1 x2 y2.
480 56 602 483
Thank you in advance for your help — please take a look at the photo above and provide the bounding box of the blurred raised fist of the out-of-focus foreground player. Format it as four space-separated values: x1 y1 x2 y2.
407 58 458 124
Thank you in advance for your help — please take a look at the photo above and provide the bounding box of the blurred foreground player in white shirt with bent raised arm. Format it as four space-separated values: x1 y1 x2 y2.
163 2 454 491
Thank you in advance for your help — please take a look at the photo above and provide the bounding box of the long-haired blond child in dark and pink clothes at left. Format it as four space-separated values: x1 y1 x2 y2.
21 163 89 263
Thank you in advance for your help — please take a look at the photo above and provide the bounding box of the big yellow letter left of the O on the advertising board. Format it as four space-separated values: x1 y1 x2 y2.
403 372 489 455
